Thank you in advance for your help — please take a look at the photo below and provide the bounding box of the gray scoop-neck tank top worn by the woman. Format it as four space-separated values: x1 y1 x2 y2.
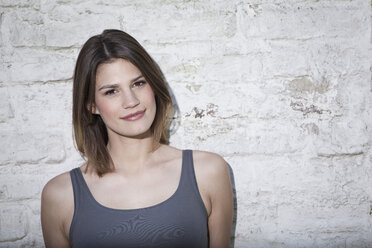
69 150 208 248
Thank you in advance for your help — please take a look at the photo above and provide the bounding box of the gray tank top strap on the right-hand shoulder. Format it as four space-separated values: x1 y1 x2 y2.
181 150 207 214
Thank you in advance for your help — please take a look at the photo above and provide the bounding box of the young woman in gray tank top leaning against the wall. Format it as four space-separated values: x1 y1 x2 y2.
41 30 233 248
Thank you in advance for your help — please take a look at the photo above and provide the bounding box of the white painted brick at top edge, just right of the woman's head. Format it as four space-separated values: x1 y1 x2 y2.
123 1 236 42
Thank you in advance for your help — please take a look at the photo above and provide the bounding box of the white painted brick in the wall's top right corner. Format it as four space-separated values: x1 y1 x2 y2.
237 1 369 39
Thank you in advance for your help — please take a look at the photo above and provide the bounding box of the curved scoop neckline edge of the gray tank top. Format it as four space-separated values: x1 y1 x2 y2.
76 150 185 212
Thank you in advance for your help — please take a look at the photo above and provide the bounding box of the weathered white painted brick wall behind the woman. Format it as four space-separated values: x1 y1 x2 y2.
0 0 372 247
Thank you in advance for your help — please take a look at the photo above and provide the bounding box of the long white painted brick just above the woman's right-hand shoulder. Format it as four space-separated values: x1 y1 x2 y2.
181 117 306 154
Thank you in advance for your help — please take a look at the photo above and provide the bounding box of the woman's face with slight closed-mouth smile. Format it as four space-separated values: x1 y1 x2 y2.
93 59 156 140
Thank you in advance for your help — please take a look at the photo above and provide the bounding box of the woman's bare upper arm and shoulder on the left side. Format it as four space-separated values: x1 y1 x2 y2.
41 173 73 248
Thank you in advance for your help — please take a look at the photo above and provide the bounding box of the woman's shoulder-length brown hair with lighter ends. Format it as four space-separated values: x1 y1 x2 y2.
72 29 172 176
